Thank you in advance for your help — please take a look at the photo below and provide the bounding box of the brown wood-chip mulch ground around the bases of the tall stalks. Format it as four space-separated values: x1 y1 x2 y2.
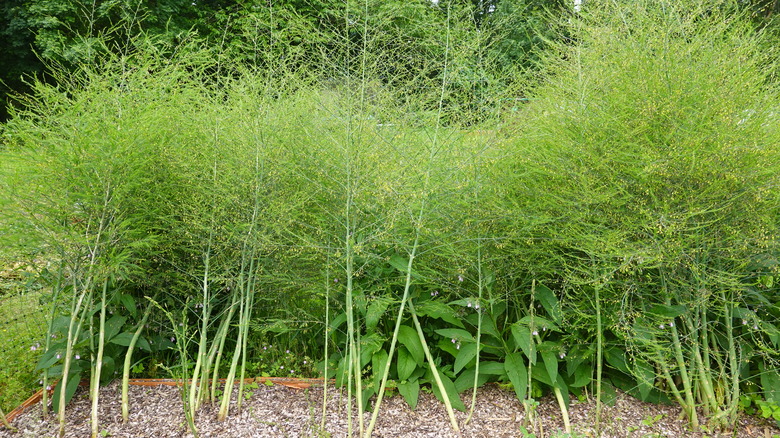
0 382 780 438
